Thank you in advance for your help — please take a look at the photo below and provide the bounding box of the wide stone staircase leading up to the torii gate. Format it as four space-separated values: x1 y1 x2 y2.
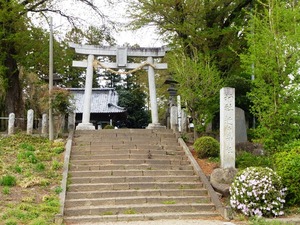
64 129 220 224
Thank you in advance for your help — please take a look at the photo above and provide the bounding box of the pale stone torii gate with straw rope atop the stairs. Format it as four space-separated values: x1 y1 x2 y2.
69 43 168 130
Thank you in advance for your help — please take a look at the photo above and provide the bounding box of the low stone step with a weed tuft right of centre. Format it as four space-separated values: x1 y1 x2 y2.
65 196 210 208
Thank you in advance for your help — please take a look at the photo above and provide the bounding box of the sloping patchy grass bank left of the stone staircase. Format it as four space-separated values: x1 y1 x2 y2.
0 133 64 225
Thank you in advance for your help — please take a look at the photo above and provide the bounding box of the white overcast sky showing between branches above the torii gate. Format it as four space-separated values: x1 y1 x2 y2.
44 0 164 47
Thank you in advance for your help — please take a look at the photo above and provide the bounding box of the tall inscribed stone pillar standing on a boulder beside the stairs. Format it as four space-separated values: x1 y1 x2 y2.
220 87 235 169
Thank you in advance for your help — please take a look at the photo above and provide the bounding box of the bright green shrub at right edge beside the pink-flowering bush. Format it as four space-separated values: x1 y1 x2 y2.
274 146 300 205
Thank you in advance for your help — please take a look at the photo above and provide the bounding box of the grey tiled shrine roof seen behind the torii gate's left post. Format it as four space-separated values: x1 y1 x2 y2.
67 88 126 113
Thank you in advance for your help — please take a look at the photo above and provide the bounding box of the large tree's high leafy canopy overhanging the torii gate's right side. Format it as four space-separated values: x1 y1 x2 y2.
129 0 254 77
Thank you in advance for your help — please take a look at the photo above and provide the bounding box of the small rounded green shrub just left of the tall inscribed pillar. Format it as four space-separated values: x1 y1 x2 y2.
194 136 220 158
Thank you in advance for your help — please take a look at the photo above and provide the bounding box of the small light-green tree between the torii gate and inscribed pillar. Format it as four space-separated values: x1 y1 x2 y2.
168 46 222 134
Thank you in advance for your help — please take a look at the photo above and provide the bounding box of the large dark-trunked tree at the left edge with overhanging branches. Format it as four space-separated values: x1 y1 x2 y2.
0 0 110 124
